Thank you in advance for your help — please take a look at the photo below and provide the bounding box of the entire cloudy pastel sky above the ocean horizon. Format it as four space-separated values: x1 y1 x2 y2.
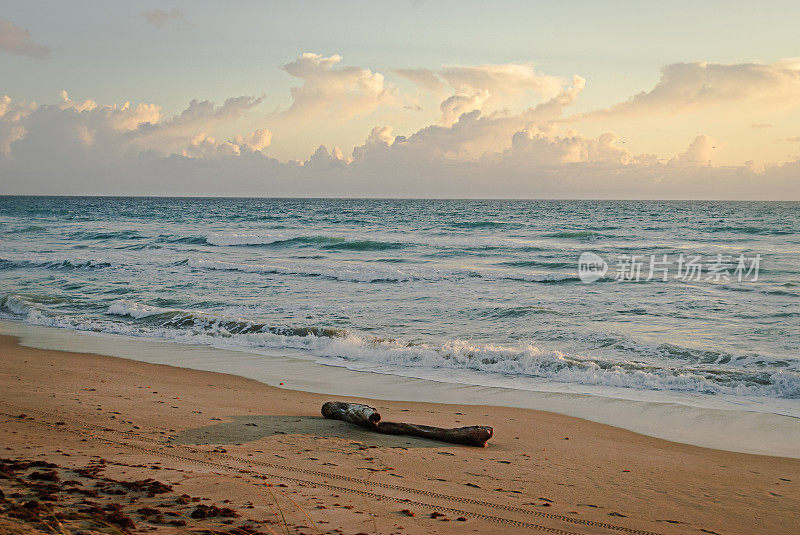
0 0 800 200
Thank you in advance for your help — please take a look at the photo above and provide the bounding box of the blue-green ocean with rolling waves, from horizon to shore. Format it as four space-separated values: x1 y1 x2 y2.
0 197 800 417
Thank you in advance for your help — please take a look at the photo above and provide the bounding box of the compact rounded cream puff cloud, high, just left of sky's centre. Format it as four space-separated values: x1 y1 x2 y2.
282 52 395 120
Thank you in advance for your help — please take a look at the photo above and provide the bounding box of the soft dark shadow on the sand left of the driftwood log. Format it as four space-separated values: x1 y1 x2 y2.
170 415 438 448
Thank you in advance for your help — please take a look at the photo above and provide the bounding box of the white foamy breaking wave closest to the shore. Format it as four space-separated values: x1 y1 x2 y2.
2 295 800 398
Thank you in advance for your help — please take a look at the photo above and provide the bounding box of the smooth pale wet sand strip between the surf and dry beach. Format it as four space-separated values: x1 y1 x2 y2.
0 320 800 458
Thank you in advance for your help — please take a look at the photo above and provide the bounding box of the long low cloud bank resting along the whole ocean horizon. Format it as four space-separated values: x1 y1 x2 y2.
0 91 800 199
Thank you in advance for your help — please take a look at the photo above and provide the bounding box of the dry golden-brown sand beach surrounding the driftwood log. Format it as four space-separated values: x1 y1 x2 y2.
0 336 800 534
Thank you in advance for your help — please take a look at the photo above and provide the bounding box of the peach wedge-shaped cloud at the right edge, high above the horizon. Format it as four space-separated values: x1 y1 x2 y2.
587 58 800 117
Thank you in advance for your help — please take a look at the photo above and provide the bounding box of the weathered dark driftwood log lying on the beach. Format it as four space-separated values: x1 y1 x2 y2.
322 401 494 447
